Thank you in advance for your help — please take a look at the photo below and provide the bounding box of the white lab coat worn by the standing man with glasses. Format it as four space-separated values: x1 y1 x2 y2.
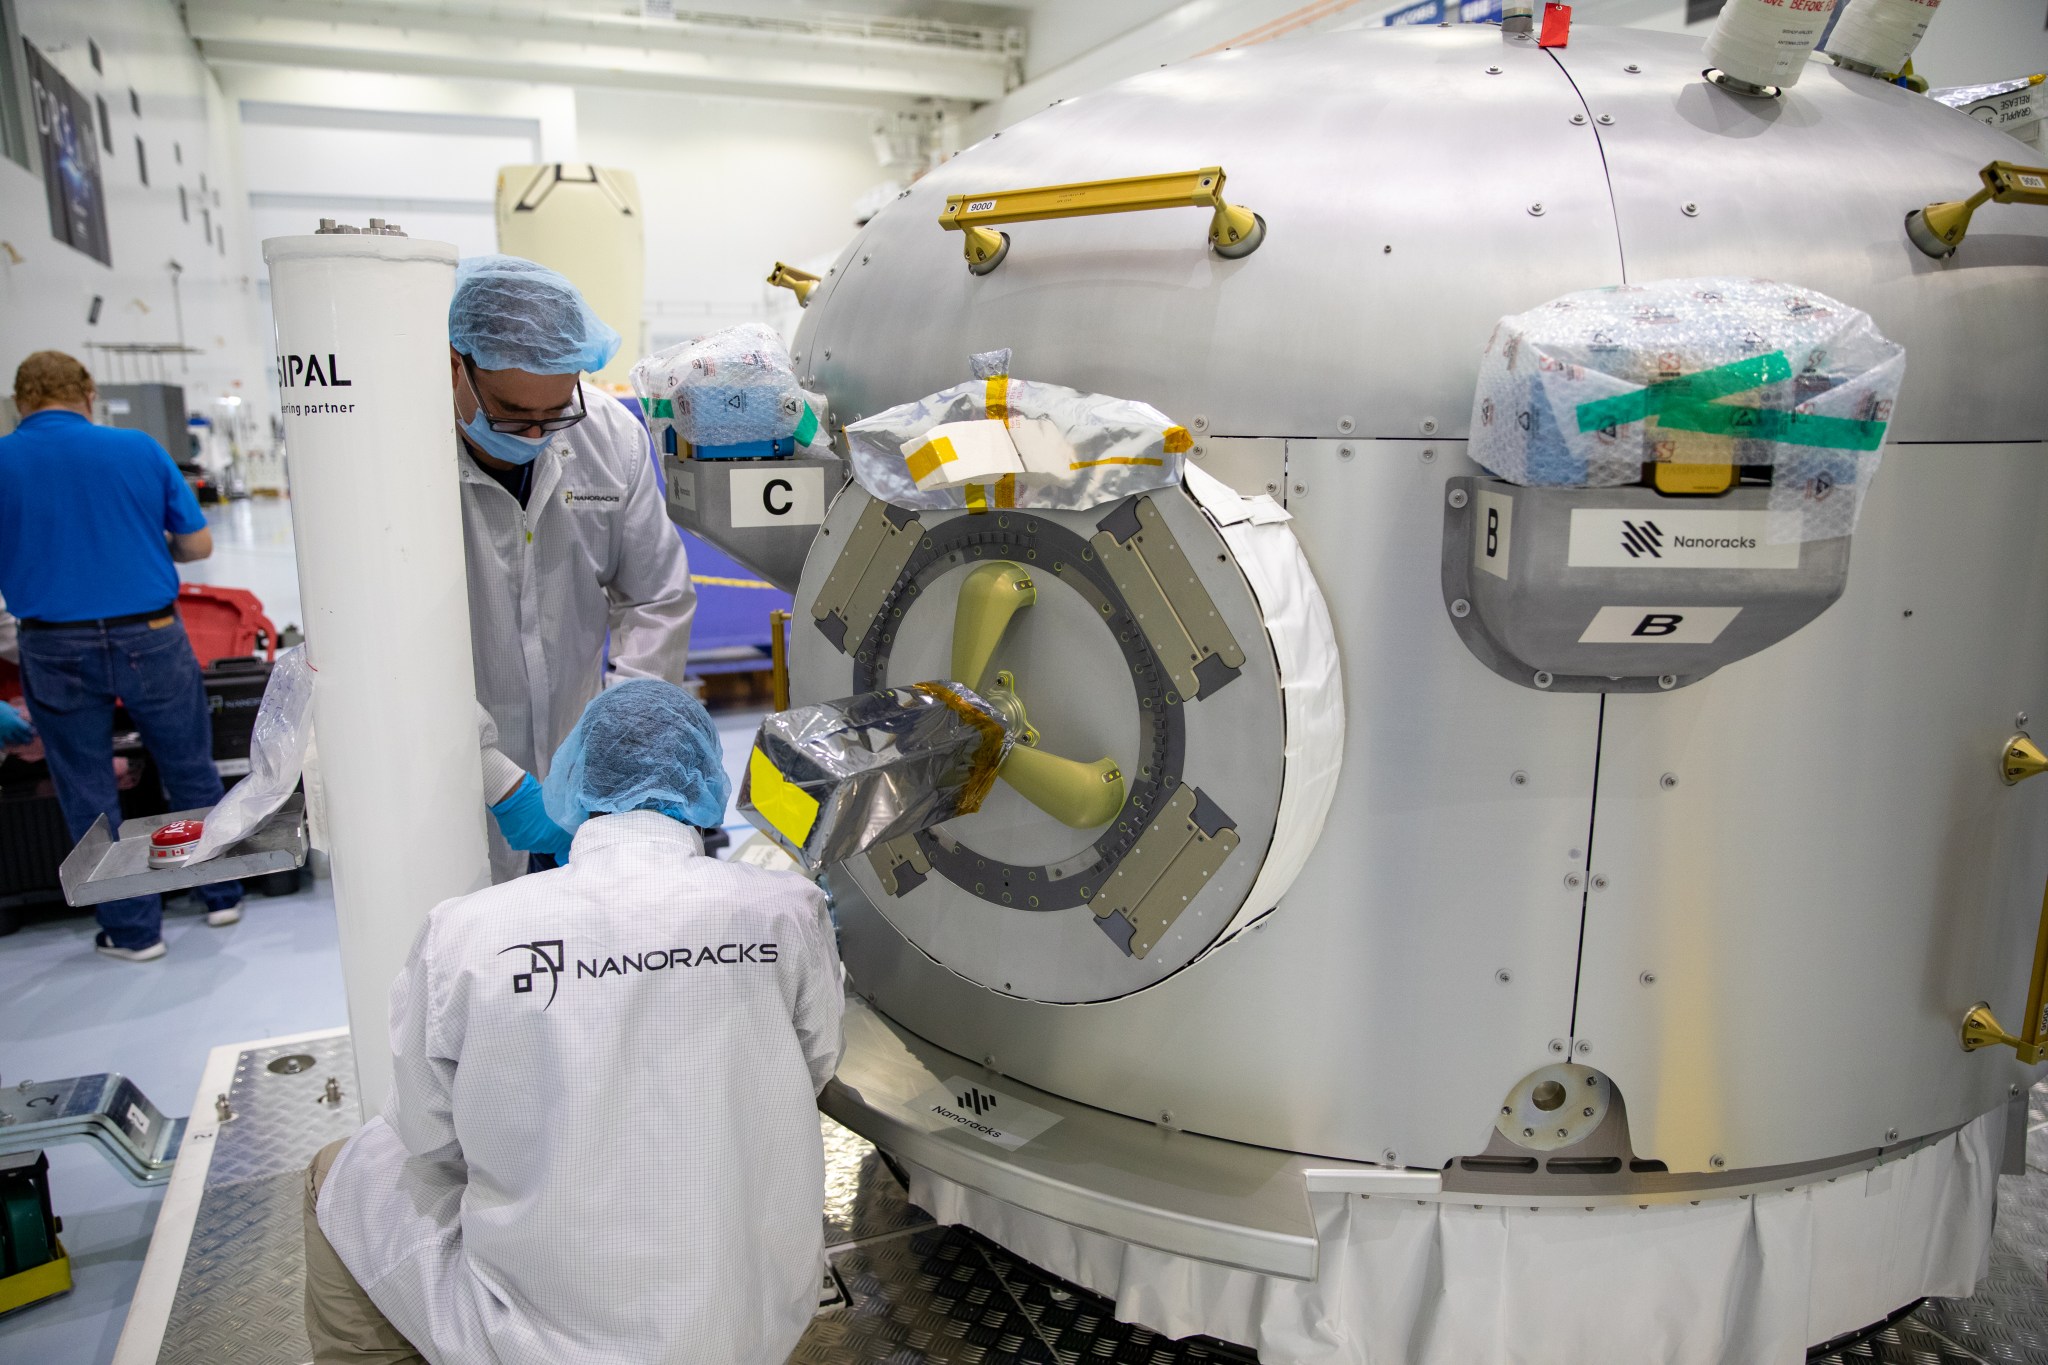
455 387 696 880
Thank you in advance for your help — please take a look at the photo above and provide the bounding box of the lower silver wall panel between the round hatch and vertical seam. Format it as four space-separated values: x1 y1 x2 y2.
811 444 1608 1169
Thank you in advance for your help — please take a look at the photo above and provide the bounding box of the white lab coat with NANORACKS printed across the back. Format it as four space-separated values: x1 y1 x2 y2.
319 810 844 1365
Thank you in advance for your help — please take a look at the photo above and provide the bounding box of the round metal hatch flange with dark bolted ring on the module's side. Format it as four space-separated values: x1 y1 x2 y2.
791 487 1286 1003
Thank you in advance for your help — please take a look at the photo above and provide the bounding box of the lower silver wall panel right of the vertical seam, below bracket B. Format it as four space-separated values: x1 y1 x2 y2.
1577 444 2048 1171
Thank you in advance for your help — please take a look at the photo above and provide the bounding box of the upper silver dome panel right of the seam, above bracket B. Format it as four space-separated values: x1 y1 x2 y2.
1548 27 2048 444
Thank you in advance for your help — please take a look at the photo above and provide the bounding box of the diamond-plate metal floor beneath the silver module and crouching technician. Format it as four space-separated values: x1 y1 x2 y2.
158 1038 2048 1365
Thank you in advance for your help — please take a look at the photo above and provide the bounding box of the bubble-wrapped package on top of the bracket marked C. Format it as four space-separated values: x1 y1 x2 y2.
633 323 803 446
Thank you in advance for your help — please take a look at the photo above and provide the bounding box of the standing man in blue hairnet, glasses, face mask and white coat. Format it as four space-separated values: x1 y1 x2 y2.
449 256 696 880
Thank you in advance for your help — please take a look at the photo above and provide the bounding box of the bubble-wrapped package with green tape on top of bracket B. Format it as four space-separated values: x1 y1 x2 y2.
1468 278 1905 544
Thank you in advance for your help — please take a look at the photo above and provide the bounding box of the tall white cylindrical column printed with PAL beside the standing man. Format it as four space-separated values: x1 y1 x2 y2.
262 233 489 1113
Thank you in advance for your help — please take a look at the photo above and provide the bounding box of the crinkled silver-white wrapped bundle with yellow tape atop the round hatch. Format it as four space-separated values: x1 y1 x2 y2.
846 350 1194 512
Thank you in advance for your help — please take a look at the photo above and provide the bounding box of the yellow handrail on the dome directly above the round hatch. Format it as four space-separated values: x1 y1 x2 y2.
938 166 1266 274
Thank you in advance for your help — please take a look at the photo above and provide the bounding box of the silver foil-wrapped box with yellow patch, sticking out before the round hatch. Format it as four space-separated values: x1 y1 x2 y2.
739 681 1014 874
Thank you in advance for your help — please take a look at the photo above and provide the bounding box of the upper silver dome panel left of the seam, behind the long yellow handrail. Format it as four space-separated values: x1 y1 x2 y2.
795 25 1622 440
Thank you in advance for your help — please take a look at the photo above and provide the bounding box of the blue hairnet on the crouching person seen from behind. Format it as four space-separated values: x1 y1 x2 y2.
541 677 731 833
